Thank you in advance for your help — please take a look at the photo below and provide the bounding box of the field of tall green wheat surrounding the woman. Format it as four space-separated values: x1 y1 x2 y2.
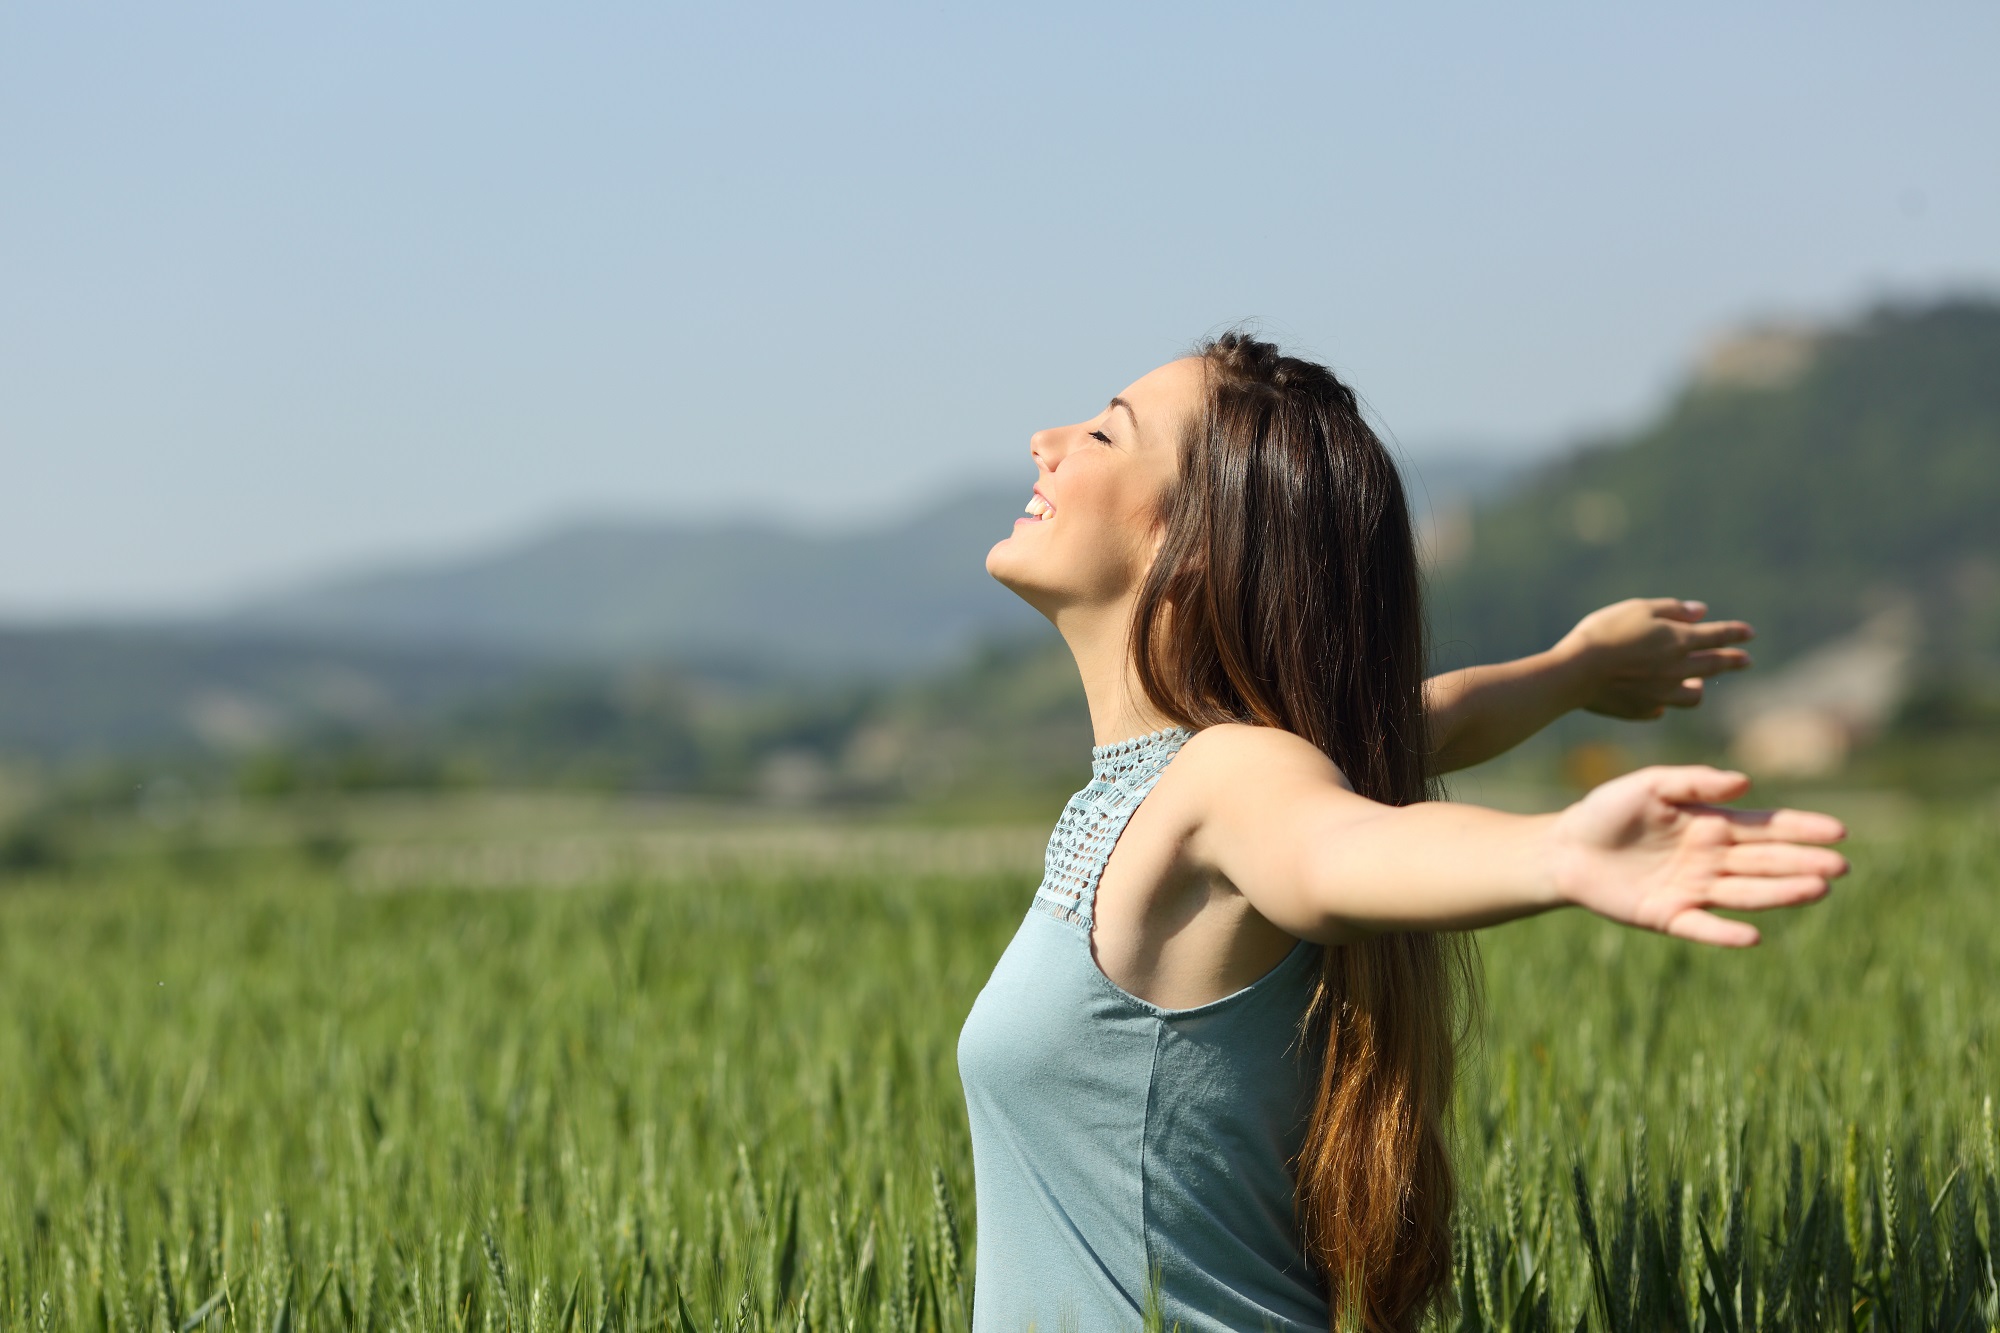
0 817 2000 1333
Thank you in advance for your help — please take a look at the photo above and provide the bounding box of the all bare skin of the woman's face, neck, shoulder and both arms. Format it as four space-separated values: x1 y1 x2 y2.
986 358 1848 1009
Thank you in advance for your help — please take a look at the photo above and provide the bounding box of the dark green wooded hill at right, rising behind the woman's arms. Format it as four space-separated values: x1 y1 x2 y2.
1432 300 2000 673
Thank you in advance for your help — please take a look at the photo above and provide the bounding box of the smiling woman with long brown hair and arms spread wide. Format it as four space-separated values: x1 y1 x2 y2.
958 334 1846 1333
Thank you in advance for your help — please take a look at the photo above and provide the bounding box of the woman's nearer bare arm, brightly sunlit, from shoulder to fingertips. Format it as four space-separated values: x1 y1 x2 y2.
1188 725 1848 947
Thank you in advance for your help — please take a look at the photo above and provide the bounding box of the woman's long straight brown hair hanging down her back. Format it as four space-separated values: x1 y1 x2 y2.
1132 332 1472 1333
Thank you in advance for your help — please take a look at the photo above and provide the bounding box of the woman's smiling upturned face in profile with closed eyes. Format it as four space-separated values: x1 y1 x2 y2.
986 356 1202 616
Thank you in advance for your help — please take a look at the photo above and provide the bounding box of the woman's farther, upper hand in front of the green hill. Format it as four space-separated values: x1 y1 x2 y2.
1554 596 1752 719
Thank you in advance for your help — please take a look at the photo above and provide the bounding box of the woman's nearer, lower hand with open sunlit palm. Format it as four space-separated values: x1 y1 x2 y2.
1548 767 1848 949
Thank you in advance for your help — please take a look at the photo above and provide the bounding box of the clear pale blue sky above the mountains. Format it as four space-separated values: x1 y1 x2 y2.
11 0 2000 618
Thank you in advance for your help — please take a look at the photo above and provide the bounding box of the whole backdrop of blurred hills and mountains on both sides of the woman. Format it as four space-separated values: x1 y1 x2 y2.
0 300 2000 793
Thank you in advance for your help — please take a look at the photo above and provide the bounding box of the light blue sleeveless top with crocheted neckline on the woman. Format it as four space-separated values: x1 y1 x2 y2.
958 729 1328 1333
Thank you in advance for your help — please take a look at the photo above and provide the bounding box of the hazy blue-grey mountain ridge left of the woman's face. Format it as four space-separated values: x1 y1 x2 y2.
232 486 1042 675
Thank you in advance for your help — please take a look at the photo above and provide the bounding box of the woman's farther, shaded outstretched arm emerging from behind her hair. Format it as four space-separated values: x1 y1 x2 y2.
1424 596 1752 773
